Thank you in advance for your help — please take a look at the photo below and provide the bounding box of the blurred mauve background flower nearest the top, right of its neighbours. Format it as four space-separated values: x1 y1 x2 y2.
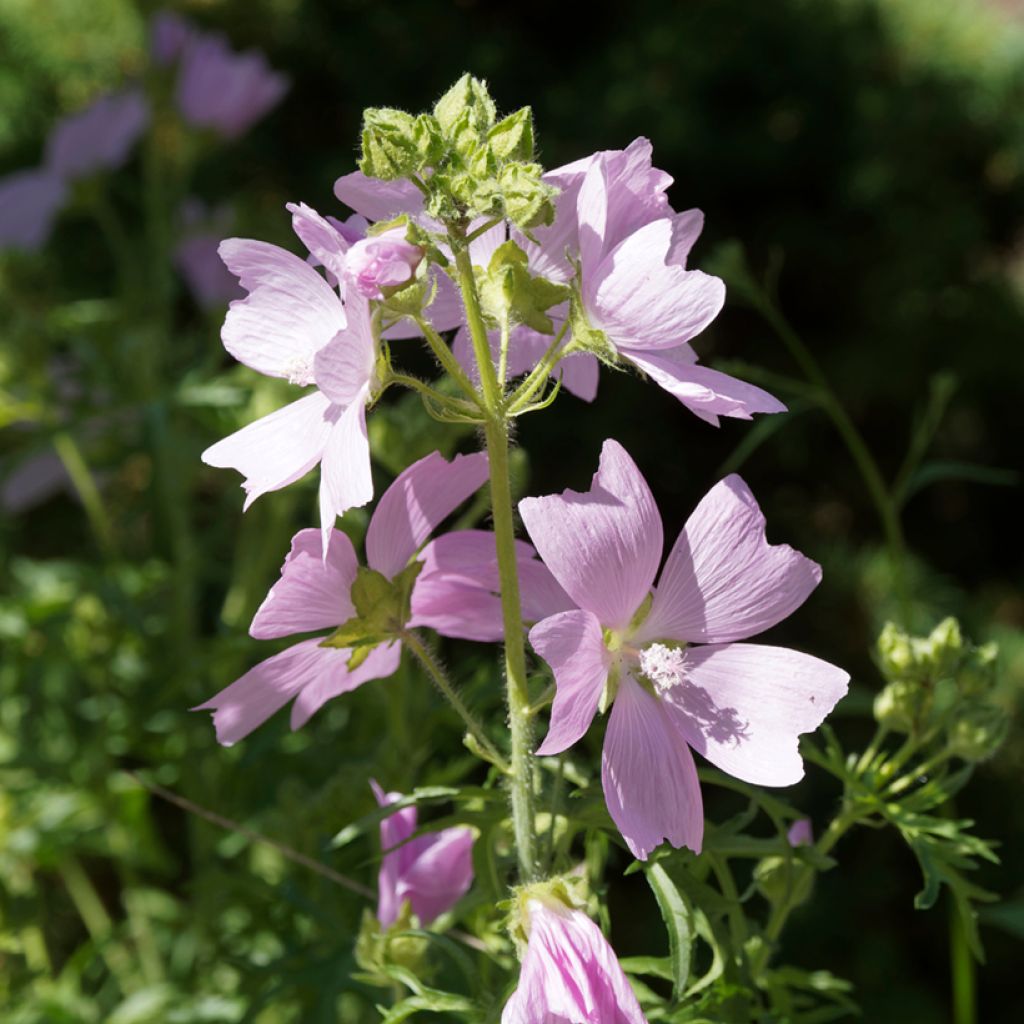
176 33 289 138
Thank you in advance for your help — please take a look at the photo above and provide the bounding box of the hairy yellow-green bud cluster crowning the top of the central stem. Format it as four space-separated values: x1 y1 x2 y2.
359 74 555 230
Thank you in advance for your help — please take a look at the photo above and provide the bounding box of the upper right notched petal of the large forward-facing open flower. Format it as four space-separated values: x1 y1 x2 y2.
635 474 821 643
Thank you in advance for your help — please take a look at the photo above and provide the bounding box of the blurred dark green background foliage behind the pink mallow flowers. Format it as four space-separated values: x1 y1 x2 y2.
0 0 1024 1024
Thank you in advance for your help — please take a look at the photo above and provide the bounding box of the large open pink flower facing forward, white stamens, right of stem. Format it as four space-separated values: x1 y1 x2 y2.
519 440 849 860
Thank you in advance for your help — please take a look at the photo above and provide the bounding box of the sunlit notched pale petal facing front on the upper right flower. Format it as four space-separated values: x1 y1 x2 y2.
583 219 725 354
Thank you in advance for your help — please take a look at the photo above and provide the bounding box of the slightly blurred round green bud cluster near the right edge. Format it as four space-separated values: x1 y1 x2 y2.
874 617 1009 761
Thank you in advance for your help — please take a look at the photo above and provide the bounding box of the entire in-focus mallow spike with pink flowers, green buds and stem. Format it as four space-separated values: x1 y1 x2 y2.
195 75 849 1024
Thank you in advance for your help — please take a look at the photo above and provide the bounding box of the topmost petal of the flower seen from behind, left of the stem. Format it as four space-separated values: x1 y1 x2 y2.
367 452 487 578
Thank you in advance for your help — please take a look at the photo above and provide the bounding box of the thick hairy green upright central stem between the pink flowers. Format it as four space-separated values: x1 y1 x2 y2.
452 237 538 882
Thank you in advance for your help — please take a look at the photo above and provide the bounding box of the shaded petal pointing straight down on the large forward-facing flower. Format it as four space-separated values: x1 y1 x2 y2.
601 676 703 860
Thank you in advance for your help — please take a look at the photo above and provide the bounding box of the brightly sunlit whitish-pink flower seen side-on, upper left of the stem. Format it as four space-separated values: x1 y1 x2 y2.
203 239 377 553
